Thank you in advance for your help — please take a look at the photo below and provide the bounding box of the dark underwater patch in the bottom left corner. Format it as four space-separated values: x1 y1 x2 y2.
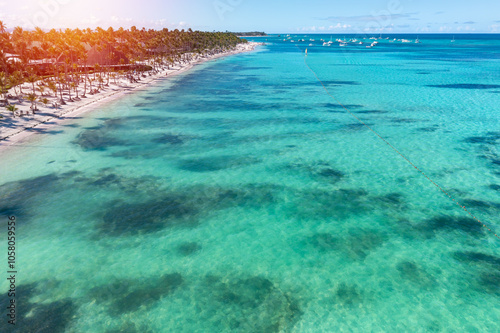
0 284 76 333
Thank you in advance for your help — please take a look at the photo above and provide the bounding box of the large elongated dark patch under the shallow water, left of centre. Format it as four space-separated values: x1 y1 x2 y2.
97 184 280 237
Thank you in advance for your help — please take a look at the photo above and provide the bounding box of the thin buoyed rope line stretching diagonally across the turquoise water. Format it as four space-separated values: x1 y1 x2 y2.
304 50 500 239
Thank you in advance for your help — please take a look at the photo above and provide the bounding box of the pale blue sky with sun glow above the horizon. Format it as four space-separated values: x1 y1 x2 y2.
0 0 500 33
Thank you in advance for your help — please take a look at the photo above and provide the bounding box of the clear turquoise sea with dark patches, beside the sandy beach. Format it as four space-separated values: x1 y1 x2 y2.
0 35 500 333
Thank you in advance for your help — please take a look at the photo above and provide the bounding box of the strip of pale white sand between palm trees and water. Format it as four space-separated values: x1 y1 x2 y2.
0 42 262 150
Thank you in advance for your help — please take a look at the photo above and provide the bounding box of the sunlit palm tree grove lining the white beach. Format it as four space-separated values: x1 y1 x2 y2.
0 21 246 114
